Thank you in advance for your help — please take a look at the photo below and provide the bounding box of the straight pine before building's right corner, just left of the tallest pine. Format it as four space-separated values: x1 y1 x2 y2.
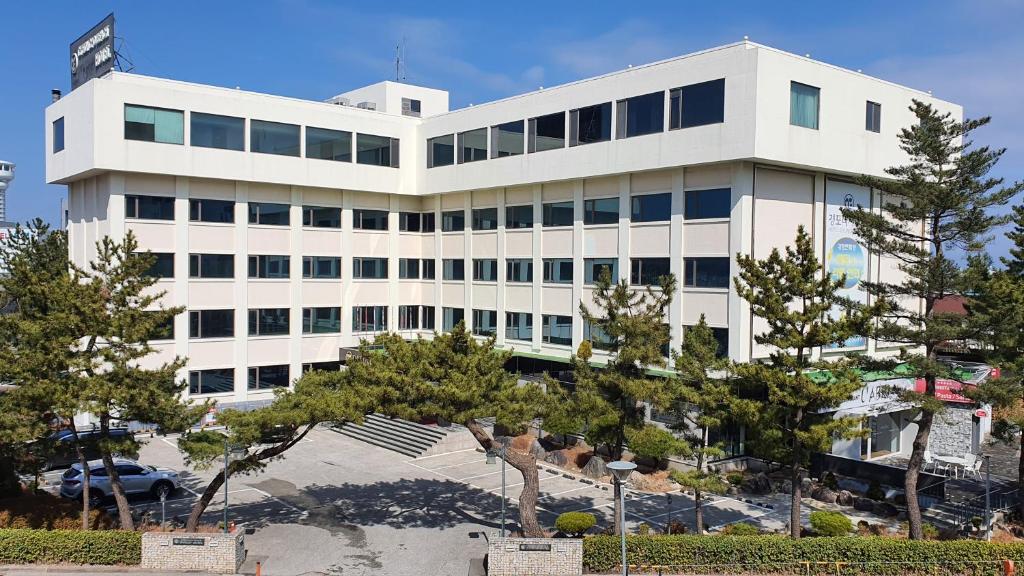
733 227 868 538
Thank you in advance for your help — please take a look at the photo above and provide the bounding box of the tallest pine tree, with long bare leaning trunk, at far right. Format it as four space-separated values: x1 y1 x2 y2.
843 100 1024 539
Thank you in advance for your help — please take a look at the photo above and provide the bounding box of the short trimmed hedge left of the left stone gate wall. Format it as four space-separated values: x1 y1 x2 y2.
0 528 142 565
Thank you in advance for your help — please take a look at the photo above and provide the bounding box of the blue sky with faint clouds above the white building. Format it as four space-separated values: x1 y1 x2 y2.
0 0 1024 255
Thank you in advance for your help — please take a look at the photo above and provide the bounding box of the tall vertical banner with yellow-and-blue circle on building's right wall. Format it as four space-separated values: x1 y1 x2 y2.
825 180 871 351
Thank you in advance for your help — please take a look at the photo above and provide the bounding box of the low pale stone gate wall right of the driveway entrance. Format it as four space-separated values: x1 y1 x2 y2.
487 538 583 576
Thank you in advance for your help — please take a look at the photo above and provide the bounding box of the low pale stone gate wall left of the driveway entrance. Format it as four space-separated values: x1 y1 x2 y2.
142 531 246 574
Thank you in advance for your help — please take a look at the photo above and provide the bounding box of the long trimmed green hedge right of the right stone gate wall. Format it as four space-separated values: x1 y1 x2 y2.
583 535 1024 576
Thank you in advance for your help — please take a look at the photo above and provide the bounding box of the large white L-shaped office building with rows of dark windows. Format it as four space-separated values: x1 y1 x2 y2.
46 42 962 426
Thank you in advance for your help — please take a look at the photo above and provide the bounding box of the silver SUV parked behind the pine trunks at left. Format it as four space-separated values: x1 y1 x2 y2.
60 458 180 505
